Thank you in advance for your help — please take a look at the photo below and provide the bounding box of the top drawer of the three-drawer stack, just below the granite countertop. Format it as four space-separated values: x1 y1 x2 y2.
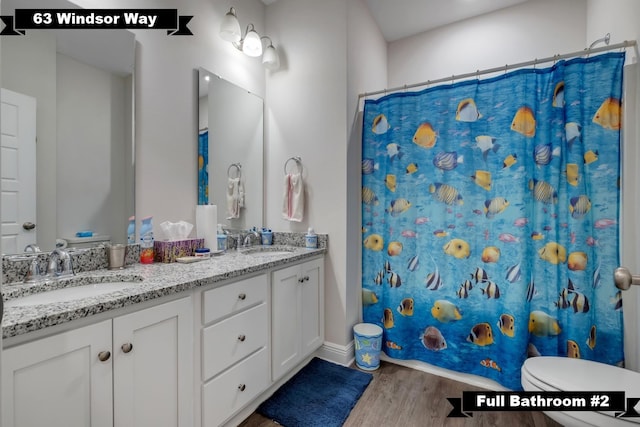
202 274 267 325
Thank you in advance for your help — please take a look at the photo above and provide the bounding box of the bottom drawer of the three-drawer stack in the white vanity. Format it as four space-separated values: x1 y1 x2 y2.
202 348 269 426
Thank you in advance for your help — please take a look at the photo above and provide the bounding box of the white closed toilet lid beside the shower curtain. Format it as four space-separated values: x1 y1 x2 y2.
522 356 640 397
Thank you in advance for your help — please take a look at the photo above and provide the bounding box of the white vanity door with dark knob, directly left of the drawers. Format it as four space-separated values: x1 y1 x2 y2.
113 297 194 427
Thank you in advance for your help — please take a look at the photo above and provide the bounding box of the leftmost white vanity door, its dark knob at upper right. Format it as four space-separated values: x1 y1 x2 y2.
1 320 113 427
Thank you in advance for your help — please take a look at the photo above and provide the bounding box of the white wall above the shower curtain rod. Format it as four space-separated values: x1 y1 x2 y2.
388 0 587 87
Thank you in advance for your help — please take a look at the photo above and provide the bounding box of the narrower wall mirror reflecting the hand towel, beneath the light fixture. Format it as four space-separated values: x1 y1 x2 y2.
198 68 264 229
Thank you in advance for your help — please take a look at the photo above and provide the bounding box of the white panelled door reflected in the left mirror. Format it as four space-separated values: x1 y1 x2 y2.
0 89 37 254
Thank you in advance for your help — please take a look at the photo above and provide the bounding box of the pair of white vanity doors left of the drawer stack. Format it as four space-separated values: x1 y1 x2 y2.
2 297 193 427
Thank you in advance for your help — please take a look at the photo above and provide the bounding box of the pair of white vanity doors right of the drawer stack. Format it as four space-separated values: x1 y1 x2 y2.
271 258 324 381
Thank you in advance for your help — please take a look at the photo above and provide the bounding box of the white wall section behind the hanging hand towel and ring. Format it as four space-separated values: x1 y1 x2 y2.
265 0 348 344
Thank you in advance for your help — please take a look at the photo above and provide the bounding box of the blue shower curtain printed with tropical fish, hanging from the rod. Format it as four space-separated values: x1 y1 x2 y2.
362 53 624 390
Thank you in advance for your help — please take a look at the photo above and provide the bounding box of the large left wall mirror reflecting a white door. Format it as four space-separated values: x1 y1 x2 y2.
0 0 136 254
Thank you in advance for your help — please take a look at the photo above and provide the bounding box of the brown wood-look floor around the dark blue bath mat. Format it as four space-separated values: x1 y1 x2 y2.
240 361 560 427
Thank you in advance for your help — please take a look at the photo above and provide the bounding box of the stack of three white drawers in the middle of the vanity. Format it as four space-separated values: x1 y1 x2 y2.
201 274 270 426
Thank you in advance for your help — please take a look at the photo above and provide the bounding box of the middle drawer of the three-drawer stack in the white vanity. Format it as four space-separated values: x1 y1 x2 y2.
202 302 269 381
